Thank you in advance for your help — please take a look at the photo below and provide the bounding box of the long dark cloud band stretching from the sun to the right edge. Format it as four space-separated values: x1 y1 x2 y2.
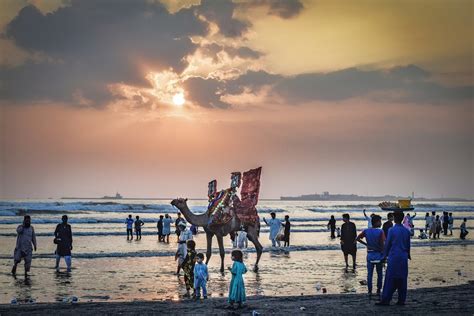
188 65 473 107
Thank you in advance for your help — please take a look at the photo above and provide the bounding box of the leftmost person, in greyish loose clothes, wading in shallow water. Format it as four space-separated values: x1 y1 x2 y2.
12 215 36 278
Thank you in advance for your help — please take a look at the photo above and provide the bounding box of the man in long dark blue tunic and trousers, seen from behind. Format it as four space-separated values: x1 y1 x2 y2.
376 212 411 305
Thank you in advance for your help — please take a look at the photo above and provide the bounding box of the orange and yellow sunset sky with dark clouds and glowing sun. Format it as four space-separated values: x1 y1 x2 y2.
0 0 474 198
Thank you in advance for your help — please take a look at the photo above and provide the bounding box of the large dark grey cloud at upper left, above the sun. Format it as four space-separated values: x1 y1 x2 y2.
0 0 208 105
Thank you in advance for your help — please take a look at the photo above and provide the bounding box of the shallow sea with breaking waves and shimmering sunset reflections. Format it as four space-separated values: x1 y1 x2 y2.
0 199 474 304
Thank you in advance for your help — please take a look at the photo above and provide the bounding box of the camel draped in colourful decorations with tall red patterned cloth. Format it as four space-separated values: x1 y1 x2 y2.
171 167 263 272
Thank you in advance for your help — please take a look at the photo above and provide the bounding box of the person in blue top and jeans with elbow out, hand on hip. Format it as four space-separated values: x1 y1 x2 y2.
356 215 385 295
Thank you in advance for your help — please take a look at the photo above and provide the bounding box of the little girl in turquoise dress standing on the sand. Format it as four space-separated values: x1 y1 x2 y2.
228 250 247 309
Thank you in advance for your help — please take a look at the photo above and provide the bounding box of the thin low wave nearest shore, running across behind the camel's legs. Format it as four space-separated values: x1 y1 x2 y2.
0 240 474 259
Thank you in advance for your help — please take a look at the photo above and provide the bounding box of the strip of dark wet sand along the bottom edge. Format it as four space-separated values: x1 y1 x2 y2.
0 281 474 315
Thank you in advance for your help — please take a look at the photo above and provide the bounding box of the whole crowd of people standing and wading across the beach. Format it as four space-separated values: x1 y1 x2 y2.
11 210 469 308
